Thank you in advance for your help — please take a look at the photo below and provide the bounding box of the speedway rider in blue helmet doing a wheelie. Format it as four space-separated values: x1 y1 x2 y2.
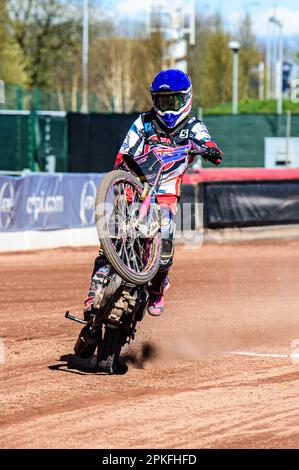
84 69 223 319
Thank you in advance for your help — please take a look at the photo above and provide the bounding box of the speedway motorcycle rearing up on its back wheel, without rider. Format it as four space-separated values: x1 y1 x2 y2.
65 143 192 374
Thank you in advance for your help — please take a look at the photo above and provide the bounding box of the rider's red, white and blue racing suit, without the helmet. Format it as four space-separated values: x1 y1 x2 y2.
85 110 222 311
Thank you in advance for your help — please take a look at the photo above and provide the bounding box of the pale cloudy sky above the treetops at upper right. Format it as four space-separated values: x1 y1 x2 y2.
110 0 299 37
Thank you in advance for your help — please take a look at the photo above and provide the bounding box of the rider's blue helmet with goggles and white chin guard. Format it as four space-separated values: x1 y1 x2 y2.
150 69 192 129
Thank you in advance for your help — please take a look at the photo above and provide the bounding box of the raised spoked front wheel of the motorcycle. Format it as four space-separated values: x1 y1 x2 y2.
95 170 161 285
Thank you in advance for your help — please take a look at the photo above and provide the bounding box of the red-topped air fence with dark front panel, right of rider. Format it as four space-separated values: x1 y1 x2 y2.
183 168 299 228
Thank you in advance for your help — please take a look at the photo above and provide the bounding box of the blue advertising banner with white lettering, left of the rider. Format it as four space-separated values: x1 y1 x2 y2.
0 173 103 232
